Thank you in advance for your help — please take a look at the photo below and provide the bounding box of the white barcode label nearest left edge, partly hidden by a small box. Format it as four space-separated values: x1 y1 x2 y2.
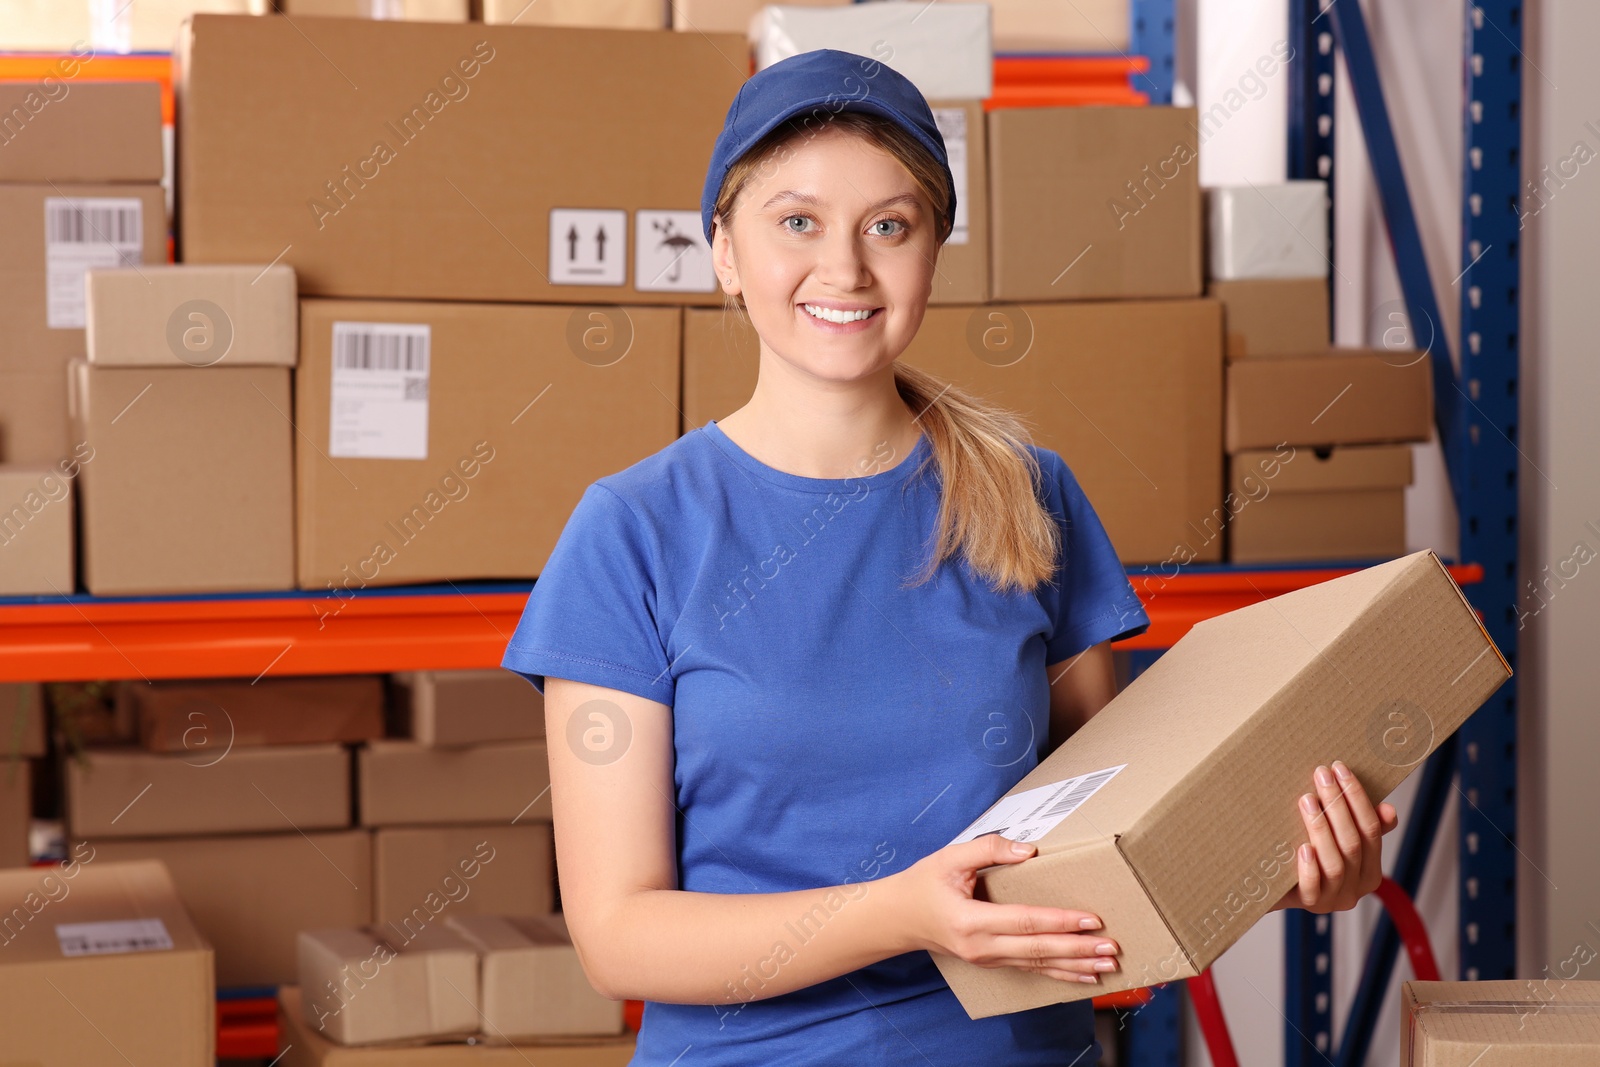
45 197 144 330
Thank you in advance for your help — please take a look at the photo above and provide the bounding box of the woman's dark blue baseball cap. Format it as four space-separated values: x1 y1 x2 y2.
701 48 955 242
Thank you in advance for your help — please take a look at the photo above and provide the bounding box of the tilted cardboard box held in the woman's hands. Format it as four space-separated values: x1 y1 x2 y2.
934 552 1510 1019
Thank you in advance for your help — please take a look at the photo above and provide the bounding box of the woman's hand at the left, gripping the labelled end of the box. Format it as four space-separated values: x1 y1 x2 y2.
890 833 1120 982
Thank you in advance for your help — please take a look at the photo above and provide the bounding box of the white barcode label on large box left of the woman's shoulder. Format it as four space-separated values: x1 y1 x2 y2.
328 322 434 459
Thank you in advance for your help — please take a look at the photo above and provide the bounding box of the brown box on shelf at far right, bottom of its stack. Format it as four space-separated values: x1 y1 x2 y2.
1227 445 1411 563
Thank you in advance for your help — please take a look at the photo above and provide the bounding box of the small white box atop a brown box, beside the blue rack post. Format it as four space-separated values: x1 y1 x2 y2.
1206 179 1333 282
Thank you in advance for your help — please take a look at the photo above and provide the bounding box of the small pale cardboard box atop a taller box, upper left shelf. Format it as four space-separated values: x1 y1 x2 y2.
85 264 299 366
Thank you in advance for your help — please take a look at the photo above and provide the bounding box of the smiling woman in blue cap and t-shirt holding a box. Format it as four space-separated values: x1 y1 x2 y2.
504 51 1395 1067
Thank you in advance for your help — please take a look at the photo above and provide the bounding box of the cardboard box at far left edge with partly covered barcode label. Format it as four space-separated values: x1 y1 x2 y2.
0 184 166 464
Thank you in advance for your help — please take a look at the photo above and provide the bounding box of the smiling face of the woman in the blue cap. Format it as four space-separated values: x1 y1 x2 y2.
714 126 939 381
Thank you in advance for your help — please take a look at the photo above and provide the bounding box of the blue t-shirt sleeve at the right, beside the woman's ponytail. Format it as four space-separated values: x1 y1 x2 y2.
1037 450 1150 664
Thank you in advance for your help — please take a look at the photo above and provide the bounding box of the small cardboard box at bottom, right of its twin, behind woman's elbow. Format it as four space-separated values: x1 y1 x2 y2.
445 913 622 1041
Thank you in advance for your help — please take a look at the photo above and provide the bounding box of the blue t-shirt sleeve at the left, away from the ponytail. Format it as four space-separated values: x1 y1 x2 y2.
501 483 674 704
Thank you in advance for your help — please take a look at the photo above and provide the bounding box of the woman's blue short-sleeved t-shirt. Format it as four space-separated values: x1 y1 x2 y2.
502 421 1149 1067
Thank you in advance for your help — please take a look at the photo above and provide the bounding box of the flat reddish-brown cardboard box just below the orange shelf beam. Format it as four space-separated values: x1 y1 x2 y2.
128 675 384 758
